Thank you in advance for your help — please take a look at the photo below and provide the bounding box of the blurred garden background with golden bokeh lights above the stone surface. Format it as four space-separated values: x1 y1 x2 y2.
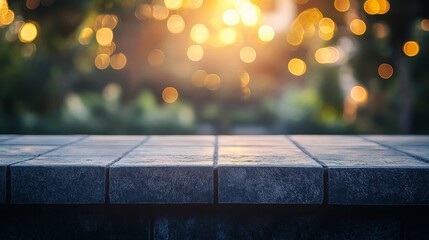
0 0 429 134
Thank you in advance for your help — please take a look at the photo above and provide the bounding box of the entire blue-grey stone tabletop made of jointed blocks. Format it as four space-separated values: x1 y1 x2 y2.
0 135 429 205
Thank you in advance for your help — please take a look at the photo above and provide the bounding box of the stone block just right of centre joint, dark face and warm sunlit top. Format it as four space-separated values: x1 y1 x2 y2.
218 143 323 204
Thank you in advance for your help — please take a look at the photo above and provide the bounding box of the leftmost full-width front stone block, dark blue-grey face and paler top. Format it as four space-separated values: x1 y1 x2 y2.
11 156 115 204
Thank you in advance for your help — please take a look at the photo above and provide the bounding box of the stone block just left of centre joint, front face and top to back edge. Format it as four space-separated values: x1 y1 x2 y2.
110 136 214 204
